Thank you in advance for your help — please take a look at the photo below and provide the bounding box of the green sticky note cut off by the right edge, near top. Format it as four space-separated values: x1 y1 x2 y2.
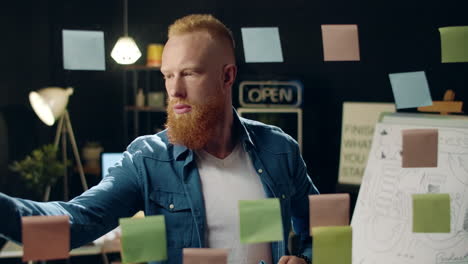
439 26 468 63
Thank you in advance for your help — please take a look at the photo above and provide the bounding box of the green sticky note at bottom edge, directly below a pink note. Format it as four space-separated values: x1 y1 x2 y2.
312 226 353 264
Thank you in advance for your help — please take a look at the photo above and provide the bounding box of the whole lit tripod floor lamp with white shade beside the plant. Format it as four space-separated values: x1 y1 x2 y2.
29 87 88 201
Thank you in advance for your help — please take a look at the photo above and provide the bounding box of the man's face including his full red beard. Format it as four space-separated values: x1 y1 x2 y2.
161 32 227 149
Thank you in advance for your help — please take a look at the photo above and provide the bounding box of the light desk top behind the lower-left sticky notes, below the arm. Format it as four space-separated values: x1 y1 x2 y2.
0 240 120 264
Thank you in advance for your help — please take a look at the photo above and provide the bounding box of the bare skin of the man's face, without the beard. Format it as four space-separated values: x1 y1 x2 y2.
161 32 224 107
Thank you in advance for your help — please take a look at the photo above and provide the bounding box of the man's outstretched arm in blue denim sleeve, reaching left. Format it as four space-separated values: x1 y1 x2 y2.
0 152 143 248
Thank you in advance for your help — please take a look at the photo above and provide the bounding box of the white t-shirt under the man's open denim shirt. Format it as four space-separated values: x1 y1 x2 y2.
195 143 272 264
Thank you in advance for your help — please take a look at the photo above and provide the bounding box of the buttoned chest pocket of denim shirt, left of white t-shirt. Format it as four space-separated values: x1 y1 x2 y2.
148 190 194 248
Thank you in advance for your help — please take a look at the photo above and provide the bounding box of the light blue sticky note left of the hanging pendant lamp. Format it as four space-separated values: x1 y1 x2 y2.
62 29 106 71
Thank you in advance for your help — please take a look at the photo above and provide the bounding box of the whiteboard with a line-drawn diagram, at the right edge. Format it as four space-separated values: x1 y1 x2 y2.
352 124 468 264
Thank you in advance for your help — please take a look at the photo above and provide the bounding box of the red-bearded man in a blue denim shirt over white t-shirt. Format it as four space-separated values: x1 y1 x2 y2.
0 15 318 264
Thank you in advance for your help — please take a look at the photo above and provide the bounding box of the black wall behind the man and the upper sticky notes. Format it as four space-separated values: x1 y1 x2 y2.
0 0 468 197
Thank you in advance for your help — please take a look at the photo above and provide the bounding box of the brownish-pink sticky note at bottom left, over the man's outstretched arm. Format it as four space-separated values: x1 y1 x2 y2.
21 215 70 261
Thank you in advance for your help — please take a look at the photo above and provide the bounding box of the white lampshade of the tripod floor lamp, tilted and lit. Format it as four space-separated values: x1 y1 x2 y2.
29 87 73 126
